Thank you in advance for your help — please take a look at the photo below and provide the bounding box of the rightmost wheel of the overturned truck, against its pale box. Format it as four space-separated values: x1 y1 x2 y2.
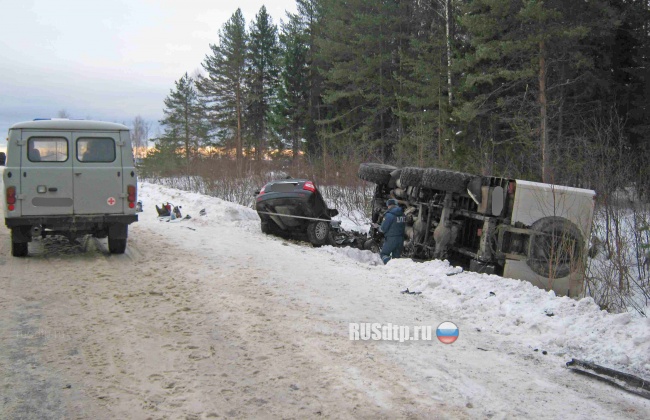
526 216 584 279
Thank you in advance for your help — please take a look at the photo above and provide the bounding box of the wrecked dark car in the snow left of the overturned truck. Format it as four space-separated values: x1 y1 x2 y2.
255 179 339 246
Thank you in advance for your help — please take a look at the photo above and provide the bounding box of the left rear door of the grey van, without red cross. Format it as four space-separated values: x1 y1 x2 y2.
19 130 73 216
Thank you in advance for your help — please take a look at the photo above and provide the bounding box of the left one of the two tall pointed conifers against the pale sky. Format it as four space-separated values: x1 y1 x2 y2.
197 9 248 161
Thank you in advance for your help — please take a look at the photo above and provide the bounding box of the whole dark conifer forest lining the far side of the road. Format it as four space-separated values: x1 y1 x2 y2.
148 0 650 193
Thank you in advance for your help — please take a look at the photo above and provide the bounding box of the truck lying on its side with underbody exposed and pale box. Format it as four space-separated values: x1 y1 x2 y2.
359 163 596 297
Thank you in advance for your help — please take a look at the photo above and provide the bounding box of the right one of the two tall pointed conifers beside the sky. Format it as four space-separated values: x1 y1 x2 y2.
246 6 280 160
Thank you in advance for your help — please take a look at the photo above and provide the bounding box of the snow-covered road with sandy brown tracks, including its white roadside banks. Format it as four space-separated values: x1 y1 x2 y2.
0 184 650 419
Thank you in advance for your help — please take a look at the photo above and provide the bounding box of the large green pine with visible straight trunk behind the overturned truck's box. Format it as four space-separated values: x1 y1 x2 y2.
455 0 608 182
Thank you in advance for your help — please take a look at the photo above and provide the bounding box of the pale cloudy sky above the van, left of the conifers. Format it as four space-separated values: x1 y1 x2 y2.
0 0 296 148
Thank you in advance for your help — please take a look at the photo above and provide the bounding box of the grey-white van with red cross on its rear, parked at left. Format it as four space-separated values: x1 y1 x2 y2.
3 119 138 257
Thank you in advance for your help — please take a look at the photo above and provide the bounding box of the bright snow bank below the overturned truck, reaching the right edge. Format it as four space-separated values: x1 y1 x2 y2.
387 259 650 377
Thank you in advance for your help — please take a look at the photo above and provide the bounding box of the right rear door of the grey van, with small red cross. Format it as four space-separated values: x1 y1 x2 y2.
72 131 125 214
